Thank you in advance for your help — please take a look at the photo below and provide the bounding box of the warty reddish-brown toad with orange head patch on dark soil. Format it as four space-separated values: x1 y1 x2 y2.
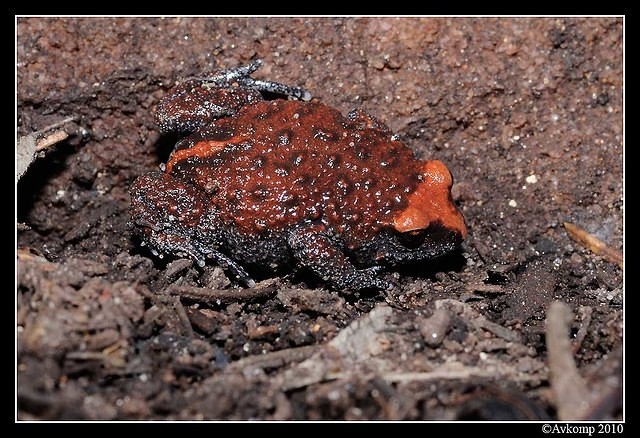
130 60 467 291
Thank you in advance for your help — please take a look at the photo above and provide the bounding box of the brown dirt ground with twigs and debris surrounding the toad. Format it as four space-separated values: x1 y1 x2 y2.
16 17 625 421
